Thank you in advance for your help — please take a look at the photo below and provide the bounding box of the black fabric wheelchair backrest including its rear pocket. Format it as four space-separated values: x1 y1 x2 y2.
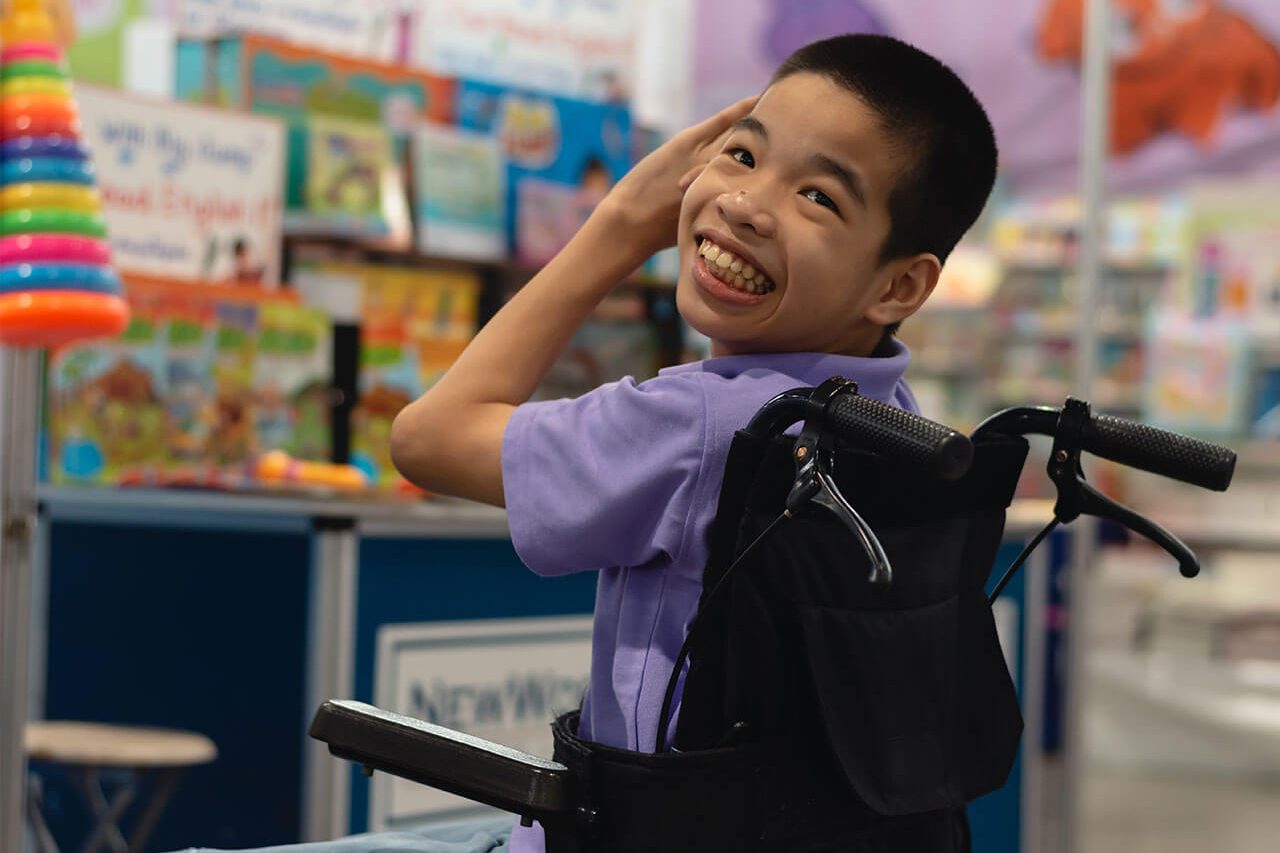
676 433 1027 816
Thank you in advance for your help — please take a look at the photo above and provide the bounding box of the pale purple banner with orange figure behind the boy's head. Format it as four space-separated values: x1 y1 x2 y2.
694 0 1280 193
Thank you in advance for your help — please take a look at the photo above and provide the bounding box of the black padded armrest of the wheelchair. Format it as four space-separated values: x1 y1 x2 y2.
311 699 572 820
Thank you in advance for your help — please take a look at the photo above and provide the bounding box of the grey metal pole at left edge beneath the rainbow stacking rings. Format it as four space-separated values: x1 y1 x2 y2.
0 347 40 850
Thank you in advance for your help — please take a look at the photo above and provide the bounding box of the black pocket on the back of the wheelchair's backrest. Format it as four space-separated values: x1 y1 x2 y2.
799 592 1021 815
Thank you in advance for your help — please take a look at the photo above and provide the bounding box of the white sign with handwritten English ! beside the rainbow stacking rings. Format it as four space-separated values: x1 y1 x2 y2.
77 86 284 283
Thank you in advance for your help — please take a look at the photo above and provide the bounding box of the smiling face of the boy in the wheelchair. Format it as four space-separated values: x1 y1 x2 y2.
676 73 900 355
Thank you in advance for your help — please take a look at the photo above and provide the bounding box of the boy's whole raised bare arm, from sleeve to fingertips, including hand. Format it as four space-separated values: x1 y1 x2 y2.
390 99 754 506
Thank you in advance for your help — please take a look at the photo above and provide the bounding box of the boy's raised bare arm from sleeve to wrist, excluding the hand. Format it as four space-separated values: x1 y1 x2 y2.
390 199 648 505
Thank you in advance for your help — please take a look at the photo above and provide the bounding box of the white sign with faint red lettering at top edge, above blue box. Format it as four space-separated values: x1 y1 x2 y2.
413 0 635 101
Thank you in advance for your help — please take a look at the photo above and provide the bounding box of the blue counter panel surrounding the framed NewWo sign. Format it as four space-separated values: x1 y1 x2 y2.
345 539 595 833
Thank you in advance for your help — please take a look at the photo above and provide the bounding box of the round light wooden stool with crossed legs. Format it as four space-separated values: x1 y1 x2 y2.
26 721 218 853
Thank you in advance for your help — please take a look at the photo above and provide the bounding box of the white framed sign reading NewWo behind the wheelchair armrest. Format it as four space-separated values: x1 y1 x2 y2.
369 616 591 833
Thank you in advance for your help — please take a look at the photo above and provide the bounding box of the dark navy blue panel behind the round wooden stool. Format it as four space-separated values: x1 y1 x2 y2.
37 523 310 850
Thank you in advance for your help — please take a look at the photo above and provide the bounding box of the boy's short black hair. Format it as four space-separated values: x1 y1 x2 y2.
771 33 997 263
